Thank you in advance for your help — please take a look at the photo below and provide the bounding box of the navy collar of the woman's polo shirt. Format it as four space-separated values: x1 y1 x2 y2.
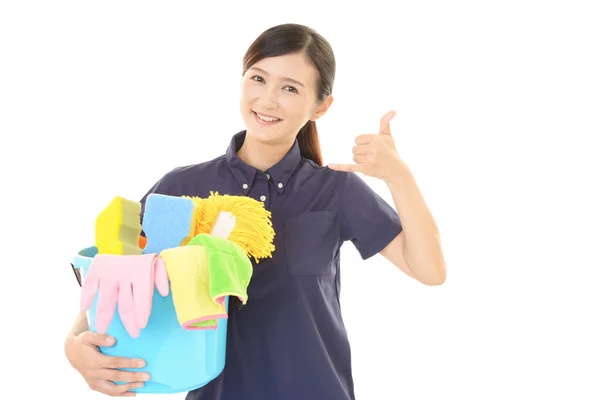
225 130 302 193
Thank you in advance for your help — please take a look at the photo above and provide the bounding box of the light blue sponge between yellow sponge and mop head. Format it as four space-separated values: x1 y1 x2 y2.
142 193 198 254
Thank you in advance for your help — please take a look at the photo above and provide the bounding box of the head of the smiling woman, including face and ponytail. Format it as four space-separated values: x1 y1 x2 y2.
240 24 335 170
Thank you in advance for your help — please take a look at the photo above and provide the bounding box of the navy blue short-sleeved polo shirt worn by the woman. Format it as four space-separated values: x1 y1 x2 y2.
142 131 402 400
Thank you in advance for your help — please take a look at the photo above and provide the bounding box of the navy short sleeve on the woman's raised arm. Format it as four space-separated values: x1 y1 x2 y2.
338 172 402 260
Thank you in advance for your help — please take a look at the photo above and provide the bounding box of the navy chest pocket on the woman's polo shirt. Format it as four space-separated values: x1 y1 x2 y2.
284 211 339 276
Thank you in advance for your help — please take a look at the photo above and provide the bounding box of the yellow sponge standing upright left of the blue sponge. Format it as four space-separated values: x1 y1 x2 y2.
96 196 142 255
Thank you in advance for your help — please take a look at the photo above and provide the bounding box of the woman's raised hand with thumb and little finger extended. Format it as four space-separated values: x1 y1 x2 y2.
328 111 402 180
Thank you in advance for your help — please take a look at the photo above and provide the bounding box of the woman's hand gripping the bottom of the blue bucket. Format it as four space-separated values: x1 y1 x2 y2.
65 331 150 397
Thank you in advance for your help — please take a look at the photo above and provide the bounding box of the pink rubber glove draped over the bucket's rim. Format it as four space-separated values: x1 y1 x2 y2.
80 254 169 338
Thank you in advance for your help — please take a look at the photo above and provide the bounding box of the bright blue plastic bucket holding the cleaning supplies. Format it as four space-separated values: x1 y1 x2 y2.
73 247 229 393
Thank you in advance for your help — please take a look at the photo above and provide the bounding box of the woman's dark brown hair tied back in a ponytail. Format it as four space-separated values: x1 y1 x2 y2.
243 24 335 166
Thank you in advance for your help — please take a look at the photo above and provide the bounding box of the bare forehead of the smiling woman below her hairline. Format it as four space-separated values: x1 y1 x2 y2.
252 53 318 87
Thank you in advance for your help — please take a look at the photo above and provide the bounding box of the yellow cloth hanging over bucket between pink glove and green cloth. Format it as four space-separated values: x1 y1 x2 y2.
160 245 227 330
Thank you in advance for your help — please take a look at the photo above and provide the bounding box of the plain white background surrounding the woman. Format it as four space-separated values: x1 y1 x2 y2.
0 0 600 400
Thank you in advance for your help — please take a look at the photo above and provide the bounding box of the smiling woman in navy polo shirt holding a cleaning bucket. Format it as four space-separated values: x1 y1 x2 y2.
65 24 445 400
